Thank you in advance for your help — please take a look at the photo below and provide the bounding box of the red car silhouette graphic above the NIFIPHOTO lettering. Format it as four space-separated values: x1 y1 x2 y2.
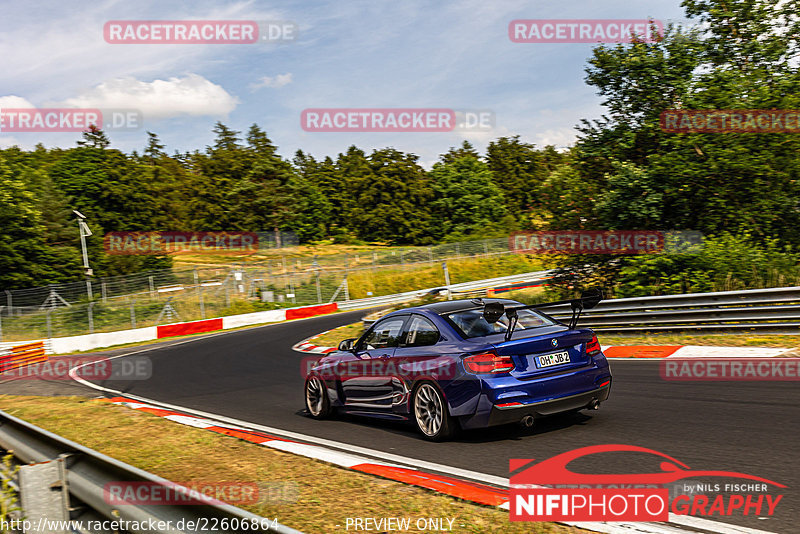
509 445 786 488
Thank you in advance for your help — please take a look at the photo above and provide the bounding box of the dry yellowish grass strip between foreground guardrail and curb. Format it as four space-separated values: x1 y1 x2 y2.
0 395 587 534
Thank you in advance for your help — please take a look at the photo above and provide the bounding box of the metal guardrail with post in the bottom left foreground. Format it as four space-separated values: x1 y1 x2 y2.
0 411 301 534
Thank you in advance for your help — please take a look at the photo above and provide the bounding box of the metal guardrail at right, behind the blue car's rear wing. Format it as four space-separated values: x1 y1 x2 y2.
543 287 800 334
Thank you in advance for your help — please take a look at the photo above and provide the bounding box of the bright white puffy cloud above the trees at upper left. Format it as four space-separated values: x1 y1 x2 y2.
61 74 239 119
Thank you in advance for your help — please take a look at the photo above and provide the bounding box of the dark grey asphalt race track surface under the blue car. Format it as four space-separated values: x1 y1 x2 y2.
97 311 800 533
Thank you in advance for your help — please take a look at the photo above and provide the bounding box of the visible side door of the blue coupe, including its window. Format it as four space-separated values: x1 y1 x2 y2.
340 315 408 411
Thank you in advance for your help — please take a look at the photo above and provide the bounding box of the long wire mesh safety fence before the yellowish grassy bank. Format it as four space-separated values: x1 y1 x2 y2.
0 241 535 342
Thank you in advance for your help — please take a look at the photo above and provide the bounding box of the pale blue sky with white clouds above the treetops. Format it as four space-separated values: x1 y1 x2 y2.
0 0 687 168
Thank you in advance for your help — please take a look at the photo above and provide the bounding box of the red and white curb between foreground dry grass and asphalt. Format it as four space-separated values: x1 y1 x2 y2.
101 397 774 534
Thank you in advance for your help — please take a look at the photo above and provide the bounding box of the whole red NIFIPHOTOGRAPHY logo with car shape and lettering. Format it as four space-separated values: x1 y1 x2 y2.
509 444 786 521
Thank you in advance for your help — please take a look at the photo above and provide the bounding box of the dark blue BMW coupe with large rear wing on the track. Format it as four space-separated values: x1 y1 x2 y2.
305 291 612 441
